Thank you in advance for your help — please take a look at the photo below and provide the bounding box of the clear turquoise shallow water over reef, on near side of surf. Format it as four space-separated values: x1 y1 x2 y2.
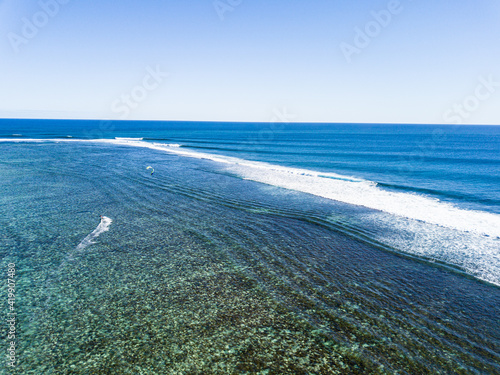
0 142 500 374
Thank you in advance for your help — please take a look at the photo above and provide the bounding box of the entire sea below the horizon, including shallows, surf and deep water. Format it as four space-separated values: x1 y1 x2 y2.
0 119 500 374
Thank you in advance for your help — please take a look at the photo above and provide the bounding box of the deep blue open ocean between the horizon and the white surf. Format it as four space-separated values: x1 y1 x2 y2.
0 120 500 213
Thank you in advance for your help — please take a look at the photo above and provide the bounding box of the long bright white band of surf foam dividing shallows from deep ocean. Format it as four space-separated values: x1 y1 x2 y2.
0 139 500 238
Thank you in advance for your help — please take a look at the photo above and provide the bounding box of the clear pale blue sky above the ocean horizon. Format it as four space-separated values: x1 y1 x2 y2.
0 0 500 125
